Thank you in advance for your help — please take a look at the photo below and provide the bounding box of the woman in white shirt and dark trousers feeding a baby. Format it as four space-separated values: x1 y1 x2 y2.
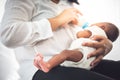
0 0 118 80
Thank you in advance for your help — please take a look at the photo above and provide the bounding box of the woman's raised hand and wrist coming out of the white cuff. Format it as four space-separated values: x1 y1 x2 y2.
48 8 82 31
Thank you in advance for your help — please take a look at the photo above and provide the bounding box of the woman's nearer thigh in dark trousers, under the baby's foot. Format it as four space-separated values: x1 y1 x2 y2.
33 66 112 80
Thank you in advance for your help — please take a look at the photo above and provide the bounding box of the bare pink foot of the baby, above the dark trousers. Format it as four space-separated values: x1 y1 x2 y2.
34 54 49 72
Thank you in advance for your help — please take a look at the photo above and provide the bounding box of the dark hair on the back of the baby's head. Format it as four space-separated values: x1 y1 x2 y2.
104 22 119 42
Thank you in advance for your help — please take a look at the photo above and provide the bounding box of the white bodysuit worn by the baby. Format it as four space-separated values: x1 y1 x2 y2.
62 26 107 70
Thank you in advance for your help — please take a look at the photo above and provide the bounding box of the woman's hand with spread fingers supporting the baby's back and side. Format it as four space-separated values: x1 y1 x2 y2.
83 35 112 66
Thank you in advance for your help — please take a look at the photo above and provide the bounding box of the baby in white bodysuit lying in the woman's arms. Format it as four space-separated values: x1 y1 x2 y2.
34 22 119 72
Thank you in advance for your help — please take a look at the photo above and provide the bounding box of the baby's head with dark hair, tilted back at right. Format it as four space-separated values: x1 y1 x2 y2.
91 22 119 42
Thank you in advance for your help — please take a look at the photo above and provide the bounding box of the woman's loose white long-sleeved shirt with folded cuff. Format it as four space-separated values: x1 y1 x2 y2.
0 0 76 80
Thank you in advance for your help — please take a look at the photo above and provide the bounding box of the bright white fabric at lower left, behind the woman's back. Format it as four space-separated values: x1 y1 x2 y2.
0 42 19 80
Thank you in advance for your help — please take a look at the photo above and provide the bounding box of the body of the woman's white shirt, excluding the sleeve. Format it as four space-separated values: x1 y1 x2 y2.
11 0 72 80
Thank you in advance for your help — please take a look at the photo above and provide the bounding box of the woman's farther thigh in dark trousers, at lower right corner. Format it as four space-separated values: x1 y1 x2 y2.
92 60 120 80
